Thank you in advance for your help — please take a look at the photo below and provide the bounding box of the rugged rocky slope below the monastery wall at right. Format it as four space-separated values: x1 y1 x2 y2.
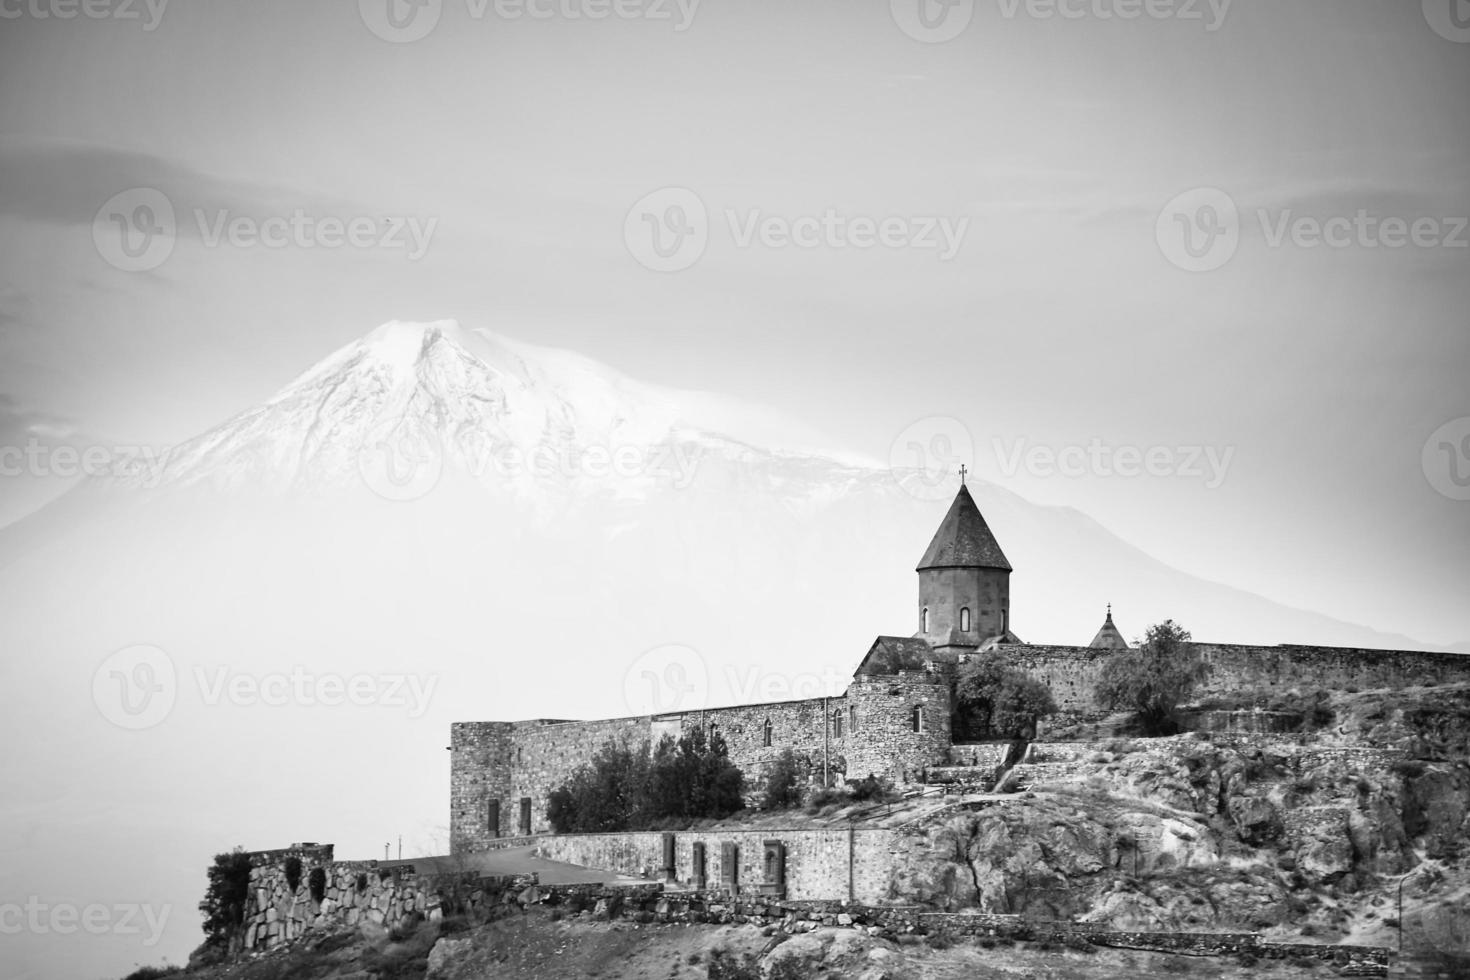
892 685 1470 945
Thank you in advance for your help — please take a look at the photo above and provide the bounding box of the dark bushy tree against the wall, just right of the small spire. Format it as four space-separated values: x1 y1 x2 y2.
1097 620 1210 735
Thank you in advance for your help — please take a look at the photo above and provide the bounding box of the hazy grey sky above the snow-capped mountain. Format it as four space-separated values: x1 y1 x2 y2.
0 0 1470 652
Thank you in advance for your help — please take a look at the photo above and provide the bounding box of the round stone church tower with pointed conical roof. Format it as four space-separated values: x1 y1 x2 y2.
917 483 1020 652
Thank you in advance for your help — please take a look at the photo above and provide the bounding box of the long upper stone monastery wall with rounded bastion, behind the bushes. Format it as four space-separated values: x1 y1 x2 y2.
450 644 1470 851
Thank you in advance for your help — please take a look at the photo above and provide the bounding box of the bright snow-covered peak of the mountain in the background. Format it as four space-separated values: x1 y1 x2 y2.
118 320 870 502
